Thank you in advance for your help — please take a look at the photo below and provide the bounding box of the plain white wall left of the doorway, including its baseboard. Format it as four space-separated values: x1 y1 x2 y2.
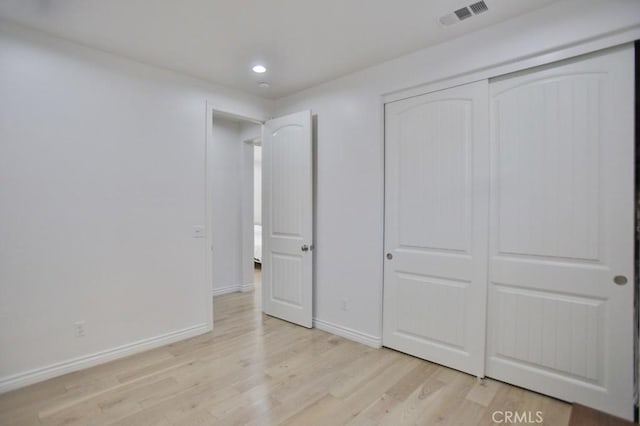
0 22 269 391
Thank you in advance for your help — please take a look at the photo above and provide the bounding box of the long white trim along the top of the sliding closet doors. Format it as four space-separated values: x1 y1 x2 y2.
382 25 640 103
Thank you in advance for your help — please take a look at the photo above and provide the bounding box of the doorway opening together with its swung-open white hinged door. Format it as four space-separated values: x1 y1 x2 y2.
206 110 314 327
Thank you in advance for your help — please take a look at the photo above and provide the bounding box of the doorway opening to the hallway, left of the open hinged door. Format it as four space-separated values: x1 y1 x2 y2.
208 110 262 296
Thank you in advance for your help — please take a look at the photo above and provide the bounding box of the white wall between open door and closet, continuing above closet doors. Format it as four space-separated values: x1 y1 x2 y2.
275 0 640 344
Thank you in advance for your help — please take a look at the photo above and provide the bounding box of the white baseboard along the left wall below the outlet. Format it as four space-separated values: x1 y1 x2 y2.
0 324 210 393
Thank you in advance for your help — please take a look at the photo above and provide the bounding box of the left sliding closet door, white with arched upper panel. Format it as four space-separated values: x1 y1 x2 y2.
383 81 489 376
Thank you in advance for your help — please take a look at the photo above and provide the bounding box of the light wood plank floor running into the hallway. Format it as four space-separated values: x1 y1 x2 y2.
0 272 571 426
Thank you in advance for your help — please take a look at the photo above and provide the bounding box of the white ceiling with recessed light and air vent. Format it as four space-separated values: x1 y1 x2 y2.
0 0 559 99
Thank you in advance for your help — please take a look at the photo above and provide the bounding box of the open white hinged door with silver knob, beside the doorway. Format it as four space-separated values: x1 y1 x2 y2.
262 111 313 327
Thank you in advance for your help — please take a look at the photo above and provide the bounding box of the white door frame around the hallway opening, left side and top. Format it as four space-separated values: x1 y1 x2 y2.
204 101 266 330
